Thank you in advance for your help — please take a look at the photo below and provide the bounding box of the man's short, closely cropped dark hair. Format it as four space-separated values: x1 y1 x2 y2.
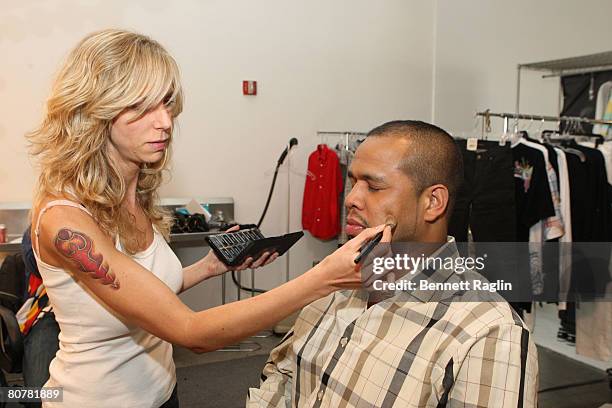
368 120 463 216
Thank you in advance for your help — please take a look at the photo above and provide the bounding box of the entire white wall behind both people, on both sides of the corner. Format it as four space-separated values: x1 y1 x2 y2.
5 0 612 307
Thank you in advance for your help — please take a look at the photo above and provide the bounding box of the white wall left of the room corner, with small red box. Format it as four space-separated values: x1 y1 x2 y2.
0 0 434 305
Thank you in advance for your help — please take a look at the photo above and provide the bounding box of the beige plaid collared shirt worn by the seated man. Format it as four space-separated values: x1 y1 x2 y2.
247 238 538 408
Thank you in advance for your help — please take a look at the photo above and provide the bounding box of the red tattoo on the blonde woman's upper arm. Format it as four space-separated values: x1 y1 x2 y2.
55 228 119 289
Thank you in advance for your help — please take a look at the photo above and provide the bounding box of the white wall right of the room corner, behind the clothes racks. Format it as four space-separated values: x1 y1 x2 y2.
434 0 612 138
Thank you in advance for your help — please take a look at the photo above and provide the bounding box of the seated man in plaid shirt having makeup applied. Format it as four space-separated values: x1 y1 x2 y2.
247 121 538 408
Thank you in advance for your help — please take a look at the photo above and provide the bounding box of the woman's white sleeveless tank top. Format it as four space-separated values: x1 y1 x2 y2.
34 200 183 407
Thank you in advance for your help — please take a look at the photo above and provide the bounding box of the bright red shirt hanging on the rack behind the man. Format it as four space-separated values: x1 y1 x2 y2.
302 144 342 239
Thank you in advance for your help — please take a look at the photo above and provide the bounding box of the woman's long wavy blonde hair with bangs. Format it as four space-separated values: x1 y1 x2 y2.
27 30 183 253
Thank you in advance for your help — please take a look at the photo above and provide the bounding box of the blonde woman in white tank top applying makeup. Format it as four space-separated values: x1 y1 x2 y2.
29 30 382 407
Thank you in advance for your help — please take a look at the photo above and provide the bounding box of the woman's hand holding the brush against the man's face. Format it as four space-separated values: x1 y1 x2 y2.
313 224 391 293
